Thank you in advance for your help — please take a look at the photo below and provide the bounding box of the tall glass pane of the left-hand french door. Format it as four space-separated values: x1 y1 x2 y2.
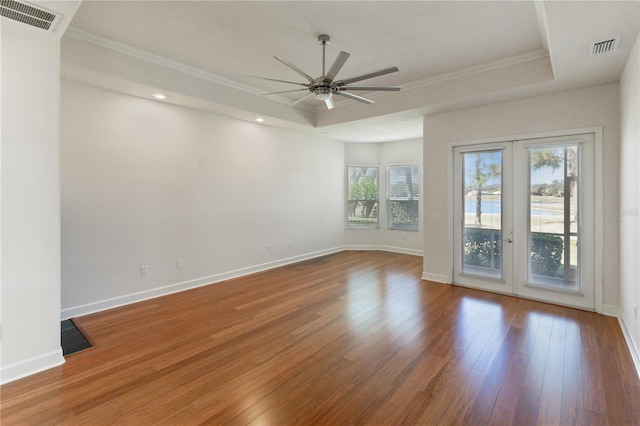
462 150 502 278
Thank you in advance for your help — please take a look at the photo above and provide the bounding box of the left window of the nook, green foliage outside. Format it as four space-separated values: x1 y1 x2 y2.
347 166 378 229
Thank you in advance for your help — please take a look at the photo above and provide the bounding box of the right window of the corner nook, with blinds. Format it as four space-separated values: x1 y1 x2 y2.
387 164 420 231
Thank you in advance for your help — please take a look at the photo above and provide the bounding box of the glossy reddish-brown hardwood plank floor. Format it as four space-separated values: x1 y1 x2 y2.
1 252 640 425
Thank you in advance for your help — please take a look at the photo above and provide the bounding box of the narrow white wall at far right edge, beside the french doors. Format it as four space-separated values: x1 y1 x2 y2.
618 35 640 374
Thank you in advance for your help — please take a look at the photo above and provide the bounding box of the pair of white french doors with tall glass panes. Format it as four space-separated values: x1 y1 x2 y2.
453 134 595 309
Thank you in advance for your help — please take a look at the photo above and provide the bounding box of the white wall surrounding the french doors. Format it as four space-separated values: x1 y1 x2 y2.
424 83 620 306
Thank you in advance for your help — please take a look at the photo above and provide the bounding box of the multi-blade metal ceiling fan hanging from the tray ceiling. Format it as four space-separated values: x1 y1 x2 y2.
251 34 402 109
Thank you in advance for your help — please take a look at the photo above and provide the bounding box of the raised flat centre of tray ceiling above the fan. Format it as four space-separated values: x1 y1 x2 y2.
72 1 542 103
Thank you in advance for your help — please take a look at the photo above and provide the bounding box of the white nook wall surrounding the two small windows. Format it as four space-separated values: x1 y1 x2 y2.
343 139 424 255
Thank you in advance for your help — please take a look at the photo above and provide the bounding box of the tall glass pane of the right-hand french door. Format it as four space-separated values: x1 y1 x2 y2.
528 144 579 291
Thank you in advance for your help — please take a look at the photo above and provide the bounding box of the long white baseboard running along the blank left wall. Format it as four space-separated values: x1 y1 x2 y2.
60 247 343 320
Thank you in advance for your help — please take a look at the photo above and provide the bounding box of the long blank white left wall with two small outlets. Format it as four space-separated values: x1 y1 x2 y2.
61 80 345 317
